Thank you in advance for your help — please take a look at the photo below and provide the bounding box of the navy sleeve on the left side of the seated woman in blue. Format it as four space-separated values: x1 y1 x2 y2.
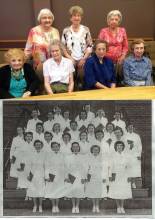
84 58 97 89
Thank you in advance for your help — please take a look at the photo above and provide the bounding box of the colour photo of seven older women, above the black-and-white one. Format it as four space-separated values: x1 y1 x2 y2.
0 0 155 99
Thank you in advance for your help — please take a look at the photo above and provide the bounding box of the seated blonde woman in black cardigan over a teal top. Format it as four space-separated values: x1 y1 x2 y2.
0 48 40 99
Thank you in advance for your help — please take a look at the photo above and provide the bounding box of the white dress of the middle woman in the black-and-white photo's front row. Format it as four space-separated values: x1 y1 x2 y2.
65 153 88 198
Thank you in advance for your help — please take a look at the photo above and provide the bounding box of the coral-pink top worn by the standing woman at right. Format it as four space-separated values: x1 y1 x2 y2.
98 27 128 62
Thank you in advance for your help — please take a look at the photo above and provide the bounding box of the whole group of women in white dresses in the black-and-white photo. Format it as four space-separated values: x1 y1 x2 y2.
10 105 142 214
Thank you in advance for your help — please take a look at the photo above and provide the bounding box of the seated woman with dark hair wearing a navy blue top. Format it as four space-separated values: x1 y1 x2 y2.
84 40 116 89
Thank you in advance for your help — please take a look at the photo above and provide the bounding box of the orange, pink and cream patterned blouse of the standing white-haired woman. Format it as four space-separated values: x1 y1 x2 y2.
25 25 60 68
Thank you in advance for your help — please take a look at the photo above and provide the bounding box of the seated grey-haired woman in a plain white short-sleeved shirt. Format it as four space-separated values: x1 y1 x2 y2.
43 40 74 94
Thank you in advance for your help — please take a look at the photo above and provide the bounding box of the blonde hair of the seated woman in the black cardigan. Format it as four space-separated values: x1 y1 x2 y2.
4 48 26 63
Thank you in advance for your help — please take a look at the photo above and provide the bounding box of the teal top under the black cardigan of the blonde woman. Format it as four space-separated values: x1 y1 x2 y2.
9 76 27 97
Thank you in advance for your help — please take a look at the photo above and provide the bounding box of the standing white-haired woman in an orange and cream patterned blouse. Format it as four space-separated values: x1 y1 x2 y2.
25 8 60 80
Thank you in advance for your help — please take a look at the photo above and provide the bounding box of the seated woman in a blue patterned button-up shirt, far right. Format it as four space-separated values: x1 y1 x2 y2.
123 39 152 86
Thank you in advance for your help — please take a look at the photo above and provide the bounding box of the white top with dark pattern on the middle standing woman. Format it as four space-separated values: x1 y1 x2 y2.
62 25 92 60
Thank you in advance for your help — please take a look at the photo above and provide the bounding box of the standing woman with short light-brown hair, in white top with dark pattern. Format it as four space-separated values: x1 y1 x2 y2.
62 6 92 88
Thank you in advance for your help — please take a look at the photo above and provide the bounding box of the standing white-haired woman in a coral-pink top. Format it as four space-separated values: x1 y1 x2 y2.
98 10 128 84
